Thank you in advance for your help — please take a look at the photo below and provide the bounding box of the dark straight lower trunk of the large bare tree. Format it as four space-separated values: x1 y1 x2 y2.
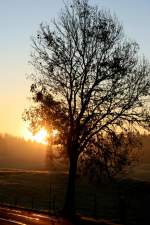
64 152 78 217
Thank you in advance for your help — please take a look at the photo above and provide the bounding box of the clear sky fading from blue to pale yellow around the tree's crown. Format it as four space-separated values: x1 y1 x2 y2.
0 0 150 136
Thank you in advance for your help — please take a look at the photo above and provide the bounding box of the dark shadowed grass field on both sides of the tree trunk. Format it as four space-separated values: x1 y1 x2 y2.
0 170 150 225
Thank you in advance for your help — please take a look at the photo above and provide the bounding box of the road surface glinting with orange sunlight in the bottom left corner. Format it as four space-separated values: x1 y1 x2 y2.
0 206 71 225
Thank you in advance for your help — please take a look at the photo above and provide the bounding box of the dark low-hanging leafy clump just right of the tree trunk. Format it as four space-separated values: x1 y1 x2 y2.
78 132 143 183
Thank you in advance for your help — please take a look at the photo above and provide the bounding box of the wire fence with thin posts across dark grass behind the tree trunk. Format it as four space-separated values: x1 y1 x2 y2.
0 174 150 225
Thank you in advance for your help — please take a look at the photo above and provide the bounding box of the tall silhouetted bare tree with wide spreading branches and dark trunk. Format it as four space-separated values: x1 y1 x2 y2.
24 0 150 215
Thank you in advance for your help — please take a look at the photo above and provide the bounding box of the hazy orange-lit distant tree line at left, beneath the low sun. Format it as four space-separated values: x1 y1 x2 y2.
0 134 46 169
